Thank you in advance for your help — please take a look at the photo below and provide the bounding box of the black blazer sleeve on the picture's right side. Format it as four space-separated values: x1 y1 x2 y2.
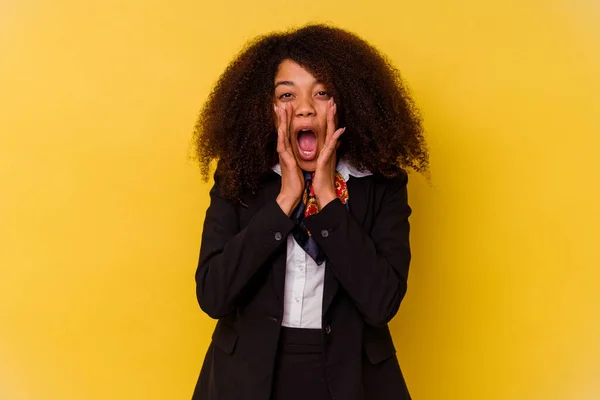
304 175 411 326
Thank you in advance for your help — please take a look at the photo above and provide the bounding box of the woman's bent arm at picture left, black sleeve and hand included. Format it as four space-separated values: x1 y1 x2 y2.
196 104 304 318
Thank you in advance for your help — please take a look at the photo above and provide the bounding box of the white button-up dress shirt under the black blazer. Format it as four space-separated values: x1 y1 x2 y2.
273 160 372 329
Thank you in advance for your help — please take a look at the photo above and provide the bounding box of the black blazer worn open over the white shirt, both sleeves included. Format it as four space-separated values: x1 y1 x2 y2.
193 172 411 400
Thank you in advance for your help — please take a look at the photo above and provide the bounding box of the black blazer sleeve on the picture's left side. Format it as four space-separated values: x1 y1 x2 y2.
196 178 294 319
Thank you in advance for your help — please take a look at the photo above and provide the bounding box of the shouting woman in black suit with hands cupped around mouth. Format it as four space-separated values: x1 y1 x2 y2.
193 25 428 400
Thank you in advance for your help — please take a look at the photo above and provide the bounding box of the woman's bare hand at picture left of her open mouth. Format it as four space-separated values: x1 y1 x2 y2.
273 103 304 216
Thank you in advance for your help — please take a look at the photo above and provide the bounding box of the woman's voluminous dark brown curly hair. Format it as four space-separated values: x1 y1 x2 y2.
194 25 428 199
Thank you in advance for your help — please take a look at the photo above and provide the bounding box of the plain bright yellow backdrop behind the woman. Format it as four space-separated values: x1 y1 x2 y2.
0 0 600 400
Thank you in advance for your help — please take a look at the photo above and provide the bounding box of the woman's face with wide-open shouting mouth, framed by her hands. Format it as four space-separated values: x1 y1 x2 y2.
274 60 331 171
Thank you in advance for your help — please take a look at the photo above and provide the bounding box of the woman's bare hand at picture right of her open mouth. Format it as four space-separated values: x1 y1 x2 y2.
312 98 346 209
